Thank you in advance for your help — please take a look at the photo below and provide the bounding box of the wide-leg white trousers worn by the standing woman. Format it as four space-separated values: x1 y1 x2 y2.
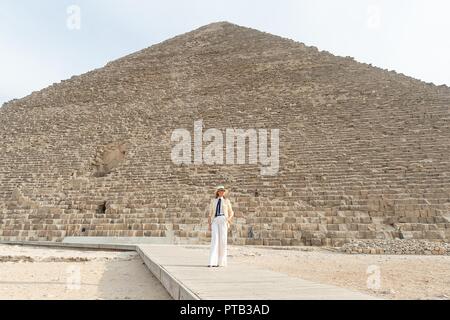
209 216 228 267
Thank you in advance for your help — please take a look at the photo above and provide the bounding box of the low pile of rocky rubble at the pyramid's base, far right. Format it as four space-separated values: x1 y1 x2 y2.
340 239 450 255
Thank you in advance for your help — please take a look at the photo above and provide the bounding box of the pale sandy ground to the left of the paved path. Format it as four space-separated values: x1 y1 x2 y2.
0 245 172 300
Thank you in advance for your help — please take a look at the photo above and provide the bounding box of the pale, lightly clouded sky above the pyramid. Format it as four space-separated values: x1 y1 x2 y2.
0 0 450 105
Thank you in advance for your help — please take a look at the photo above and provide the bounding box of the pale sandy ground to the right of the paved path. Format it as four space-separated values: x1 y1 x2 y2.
228 246 450 300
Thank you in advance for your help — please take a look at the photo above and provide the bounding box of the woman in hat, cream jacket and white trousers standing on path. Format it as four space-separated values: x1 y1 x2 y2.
208 185 234 267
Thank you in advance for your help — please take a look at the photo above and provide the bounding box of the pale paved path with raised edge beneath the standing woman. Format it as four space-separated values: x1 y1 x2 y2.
137 244 376 300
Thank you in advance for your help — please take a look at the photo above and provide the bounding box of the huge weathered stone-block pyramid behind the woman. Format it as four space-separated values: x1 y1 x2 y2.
0 22 450 246
